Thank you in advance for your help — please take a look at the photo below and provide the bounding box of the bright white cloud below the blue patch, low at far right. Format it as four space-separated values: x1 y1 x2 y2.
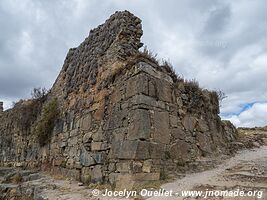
224 103 267 127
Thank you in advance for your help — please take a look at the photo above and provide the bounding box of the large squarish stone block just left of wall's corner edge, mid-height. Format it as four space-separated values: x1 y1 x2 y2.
127 109 151 140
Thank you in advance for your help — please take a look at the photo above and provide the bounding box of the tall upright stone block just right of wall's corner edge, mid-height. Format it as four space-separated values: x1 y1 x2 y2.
153 111 170 144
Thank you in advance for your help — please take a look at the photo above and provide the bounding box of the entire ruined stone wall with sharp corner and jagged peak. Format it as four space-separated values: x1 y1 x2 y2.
0 11 239 188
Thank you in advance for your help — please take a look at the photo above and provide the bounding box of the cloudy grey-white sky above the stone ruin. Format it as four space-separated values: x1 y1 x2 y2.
0 0 267 127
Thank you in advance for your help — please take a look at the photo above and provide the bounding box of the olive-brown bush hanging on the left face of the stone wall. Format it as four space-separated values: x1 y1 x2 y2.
36 99 59 146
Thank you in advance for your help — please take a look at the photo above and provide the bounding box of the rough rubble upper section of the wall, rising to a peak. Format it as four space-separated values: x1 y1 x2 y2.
54 11 143 101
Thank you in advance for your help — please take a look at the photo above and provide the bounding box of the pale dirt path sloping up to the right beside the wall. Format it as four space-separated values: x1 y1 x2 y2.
150 146 267 200
